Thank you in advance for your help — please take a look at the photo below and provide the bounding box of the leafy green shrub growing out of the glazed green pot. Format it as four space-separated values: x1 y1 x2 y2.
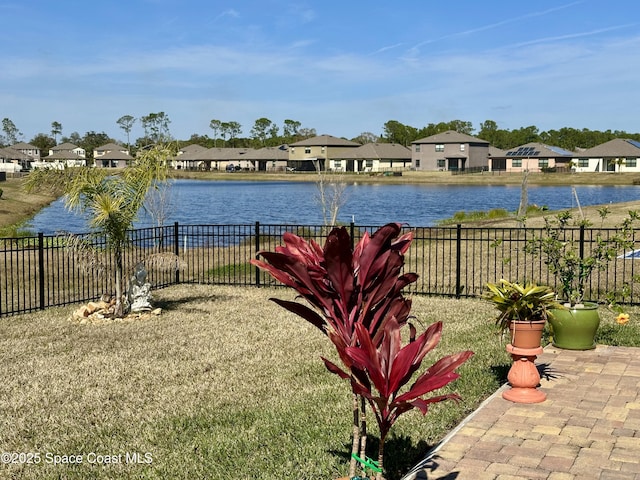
525 209 639 306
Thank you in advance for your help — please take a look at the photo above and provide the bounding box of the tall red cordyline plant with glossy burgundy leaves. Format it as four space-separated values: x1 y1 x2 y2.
251 223 471 477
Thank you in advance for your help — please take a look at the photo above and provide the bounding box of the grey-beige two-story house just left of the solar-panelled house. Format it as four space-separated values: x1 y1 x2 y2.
411 130 489 171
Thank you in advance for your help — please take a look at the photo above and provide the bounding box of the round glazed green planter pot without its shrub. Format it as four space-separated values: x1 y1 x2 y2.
549 302 600 350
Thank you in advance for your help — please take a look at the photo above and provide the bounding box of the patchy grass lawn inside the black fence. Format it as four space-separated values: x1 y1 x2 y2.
0 285 640 480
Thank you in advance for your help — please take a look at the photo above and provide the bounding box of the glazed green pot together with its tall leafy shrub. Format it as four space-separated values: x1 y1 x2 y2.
526 209 638 350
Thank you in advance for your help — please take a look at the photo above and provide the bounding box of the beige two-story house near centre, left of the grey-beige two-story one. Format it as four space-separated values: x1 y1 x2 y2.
288 135 361 172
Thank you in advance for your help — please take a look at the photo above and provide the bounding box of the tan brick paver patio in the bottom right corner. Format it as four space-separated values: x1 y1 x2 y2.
405 346 640 480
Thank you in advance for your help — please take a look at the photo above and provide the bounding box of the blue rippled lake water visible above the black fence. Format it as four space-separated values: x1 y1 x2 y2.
25 180 640 234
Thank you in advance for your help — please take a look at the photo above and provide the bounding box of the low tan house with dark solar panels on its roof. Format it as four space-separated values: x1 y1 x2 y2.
489 142 575 172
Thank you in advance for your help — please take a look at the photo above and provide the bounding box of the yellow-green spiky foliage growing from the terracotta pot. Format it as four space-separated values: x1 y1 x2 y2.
485 279 562 333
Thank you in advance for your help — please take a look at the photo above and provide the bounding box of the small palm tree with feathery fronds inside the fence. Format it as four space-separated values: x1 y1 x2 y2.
25 145 173 317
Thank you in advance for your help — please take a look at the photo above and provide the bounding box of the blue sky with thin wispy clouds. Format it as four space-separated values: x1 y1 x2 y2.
0 0 640 140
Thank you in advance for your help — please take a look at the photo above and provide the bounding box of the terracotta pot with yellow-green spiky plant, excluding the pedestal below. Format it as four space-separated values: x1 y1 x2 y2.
485 279 562 348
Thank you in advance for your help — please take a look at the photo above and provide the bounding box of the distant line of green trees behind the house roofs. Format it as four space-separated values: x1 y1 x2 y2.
0 112 640 159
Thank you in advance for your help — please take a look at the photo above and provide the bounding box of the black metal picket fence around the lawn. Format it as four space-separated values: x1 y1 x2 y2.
0 223 640 316
